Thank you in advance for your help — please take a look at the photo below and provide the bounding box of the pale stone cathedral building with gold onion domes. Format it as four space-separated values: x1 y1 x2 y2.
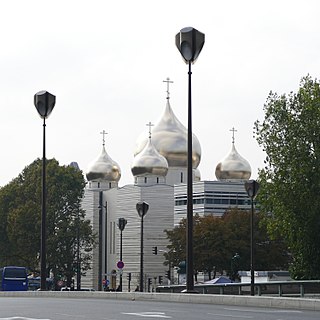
81 84 251 291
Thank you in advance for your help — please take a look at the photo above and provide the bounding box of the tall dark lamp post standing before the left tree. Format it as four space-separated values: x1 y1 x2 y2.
34 91 56 290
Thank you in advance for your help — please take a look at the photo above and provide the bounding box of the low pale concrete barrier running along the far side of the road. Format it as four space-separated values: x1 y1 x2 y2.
0 291 320 311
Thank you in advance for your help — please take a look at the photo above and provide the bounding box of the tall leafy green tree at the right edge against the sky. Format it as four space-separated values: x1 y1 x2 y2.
255 76 320 279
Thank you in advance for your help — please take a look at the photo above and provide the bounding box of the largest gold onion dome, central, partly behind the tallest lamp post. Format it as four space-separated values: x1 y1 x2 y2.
134 99 201 168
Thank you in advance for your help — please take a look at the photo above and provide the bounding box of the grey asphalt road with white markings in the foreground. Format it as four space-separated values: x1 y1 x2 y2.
0 297 320 320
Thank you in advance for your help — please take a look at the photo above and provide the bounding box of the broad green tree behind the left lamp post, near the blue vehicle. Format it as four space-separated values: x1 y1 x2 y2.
0 159 95 285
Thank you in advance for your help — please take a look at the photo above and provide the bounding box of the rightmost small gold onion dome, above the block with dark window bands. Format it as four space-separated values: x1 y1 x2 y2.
216 143 251 180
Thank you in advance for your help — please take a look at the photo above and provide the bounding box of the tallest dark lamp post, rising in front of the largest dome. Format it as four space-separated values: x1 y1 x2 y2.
176 27 204 293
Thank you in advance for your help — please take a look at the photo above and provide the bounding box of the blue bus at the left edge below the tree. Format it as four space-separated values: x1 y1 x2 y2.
0 266 28 291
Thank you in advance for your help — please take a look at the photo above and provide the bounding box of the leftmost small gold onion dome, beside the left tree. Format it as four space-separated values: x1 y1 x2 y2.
86 146 121 182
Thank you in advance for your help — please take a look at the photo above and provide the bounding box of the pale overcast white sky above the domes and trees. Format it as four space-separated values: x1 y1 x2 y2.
0 0 320 186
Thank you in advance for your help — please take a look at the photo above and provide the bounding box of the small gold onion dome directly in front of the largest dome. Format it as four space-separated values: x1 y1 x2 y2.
131 139 168 177
